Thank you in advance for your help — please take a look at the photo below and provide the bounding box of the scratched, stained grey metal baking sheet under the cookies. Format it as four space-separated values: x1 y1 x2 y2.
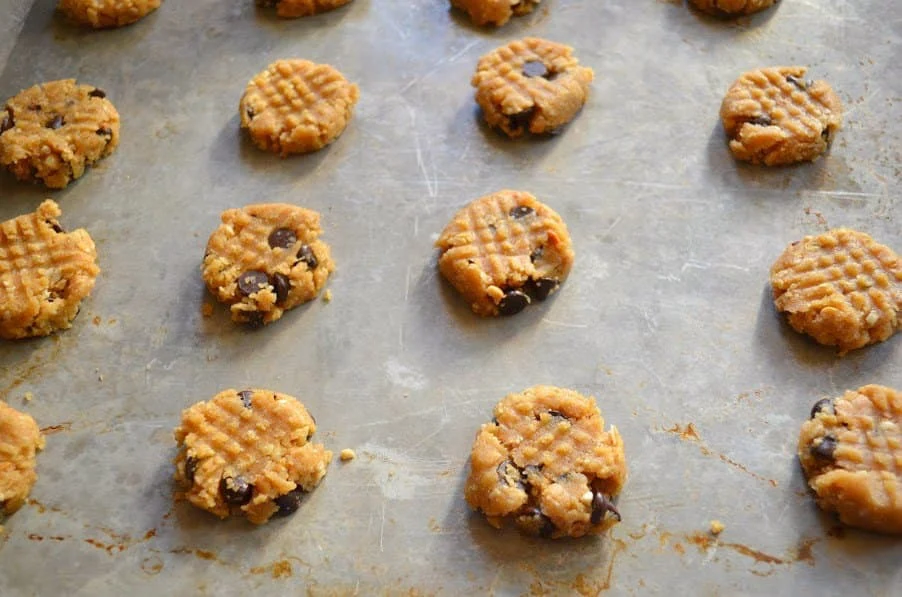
0 0 902 597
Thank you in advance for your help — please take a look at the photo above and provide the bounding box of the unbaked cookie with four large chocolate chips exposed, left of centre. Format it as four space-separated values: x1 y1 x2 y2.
203 203 335 325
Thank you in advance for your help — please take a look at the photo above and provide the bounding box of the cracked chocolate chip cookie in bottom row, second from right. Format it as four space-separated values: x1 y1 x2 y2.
465 386 627 537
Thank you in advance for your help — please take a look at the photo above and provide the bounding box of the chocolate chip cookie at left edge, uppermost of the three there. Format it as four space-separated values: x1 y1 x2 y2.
0 79 119 189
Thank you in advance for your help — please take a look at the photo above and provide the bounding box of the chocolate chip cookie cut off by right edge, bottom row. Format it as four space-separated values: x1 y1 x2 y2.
799 385 902 534
